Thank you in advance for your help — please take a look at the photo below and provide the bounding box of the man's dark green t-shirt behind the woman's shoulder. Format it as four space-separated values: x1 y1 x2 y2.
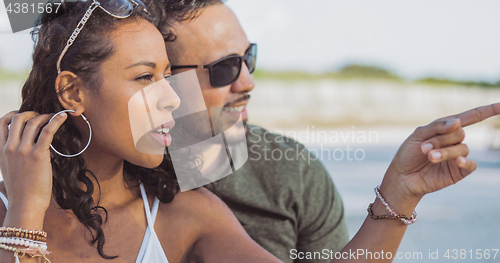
205 125 349 262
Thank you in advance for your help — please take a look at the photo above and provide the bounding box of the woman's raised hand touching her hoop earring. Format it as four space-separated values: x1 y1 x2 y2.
0 111 66 213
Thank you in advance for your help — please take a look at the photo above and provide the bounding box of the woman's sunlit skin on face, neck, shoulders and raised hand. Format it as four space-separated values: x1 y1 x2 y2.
0 20 275 263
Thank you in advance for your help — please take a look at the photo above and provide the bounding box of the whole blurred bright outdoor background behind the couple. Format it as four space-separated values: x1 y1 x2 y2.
0 0 500 262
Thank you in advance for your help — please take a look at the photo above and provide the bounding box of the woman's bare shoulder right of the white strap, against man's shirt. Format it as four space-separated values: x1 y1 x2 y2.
155 187 278 262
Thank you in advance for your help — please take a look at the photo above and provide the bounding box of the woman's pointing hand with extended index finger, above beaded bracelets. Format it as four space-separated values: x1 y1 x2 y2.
381 103 500 213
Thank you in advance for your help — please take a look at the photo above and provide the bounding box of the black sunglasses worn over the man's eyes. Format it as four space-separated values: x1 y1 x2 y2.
172 43 257 88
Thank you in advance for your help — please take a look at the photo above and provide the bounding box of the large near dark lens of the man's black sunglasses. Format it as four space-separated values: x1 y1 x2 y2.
210 57 242 87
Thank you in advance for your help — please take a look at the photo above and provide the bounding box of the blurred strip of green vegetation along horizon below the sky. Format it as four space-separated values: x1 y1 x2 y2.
254 64 500 88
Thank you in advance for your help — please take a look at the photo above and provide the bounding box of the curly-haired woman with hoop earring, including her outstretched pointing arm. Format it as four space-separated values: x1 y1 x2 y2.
0 0 500 263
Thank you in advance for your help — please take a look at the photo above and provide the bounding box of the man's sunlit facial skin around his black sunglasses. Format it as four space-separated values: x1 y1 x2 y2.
166 5 254 122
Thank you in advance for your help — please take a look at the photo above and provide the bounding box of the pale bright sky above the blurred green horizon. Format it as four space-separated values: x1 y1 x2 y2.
0 0 500 81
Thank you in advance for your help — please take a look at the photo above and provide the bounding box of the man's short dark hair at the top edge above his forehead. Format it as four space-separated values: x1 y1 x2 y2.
151 0 225 41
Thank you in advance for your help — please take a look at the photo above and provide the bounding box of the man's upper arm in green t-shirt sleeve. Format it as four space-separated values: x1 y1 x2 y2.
295 152 349 262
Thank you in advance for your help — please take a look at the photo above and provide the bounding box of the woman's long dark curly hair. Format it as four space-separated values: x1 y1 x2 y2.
19 0 199 259
